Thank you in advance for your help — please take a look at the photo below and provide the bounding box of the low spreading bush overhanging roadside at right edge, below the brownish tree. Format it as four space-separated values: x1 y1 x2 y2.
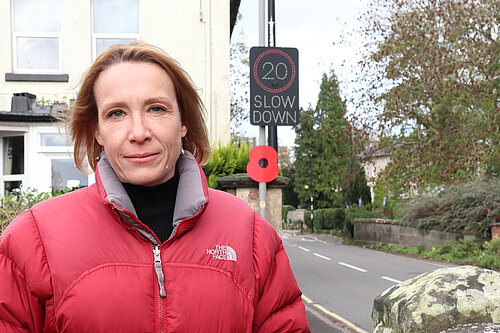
400 178 500 239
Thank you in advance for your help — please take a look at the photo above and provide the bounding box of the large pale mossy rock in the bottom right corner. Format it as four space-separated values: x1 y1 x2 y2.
372 266 500 333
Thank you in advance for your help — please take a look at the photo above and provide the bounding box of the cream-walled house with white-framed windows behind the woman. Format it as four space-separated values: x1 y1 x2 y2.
0 0 230 195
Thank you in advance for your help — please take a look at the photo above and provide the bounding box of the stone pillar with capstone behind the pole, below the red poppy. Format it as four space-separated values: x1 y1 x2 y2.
217 173 289 236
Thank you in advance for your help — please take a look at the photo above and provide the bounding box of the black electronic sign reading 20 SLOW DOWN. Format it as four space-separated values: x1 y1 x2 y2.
250 47 299 126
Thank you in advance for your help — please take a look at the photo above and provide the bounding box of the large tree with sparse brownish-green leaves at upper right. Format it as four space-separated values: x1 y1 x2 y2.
360 0 500 191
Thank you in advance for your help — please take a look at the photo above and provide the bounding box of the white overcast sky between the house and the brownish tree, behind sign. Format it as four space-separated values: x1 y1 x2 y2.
232 0 369 146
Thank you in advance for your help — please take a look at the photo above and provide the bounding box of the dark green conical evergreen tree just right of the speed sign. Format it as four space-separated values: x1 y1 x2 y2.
294 71 369 208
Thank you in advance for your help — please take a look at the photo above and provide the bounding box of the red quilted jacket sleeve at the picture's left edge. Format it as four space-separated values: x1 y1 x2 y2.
0 211 49 332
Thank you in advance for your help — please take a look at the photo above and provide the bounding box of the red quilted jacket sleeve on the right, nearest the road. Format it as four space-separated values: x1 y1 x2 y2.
253 214 310 332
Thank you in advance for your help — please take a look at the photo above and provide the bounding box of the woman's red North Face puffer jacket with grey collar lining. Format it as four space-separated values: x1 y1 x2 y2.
0 155 309 332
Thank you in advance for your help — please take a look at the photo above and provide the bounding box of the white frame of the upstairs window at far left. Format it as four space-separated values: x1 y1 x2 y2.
11 0 62 74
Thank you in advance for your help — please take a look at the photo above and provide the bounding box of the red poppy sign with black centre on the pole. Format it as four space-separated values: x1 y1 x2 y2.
247 146 280 183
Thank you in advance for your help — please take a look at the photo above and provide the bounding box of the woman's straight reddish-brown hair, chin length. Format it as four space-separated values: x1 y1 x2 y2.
68 42 210 171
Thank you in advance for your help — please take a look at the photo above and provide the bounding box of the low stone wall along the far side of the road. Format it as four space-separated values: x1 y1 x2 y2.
354 218 462 250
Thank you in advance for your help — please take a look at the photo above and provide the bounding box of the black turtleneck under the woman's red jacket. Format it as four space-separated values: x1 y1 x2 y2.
122 172 179 242
